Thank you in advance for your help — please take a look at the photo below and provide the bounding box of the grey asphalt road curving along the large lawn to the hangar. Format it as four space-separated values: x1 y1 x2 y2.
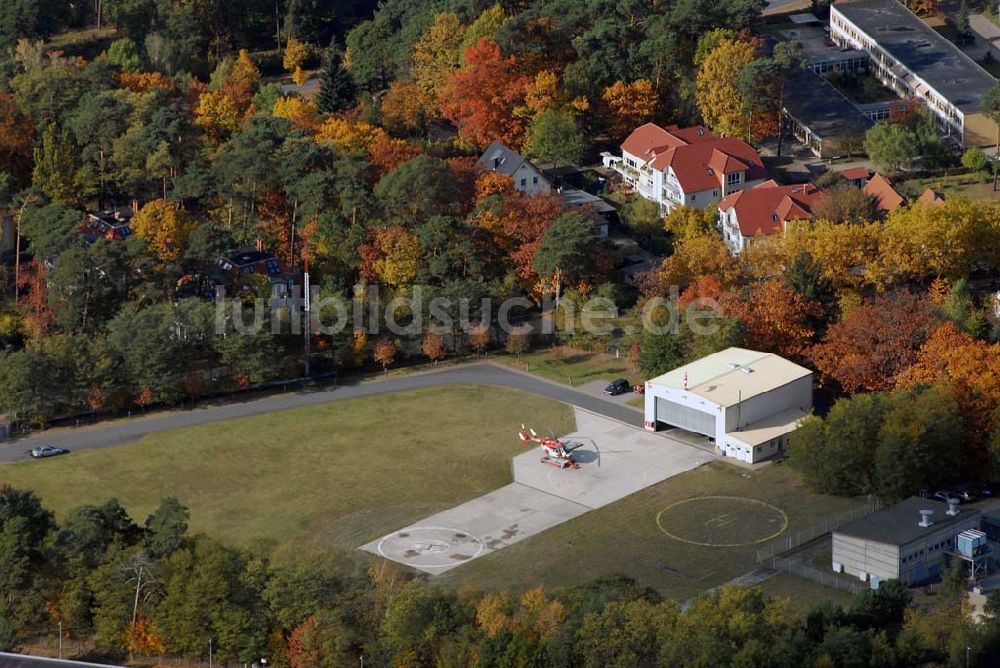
0 363 642 468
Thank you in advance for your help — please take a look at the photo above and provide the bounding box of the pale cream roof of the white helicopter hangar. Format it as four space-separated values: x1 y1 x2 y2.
649 348 812 408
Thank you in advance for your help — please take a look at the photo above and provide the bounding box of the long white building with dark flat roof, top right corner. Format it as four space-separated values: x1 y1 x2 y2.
830 0 997 146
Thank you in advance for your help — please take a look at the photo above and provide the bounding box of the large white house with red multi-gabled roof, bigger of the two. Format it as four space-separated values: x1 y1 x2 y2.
604 123 767 213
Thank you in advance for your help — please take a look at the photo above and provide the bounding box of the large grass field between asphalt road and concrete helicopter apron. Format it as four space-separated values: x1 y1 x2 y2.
0 386 575 559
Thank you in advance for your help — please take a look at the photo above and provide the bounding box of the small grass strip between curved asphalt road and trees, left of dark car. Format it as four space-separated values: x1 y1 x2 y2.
492 347 640 386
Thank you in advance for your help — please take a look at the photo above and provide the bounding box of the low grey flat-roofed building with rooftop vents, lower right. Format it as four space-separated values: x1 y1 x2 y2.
831 497 982 585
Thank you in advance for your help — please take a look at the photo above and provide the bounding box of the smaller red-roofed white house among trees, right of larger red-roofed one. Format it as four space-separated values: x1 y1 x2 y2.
719 181 826 255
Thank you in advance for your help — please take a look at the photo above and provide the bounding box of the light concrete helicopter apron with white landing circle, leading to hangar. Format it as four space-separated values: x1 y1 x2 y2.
361 408 714 574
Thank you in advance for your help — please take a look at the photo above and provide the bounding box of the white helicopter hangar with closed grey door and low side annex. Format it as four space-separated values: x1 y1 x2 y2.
645 348 812 464
